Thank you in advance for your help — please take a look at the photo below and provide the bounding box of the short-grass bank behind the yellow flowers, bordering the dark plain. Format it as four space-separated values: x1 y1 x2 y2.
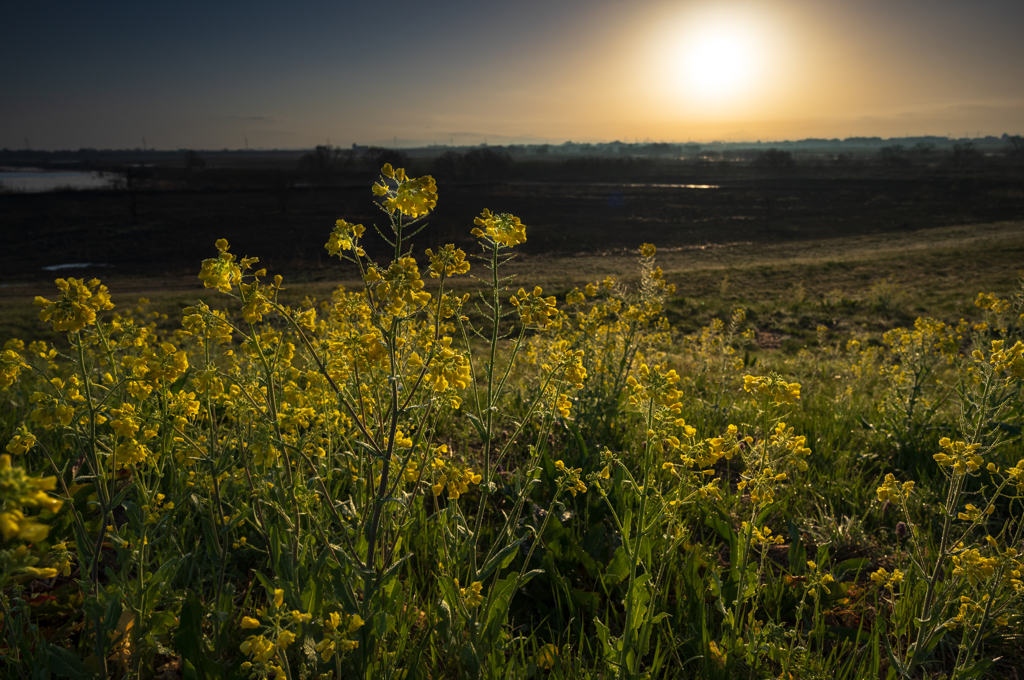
0 222 1024 341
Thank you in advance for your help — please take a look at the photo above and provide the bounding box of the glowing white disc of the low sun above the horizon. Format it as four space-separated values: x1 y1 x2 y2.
682 30 757 100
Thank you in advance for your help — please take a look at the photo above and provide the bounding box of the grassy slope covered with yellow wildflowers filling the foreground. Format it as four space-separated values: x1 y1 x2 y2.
0 165 1024 680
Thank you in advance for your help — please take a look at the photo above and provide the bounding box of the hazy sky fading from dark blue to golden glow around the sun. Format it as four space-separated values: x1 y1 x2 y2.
0 0 1024 150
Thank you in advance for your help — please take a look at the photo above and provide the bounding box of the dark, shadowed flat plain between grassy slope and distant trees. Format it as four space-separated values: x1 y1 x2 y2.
0 165 1024 284
